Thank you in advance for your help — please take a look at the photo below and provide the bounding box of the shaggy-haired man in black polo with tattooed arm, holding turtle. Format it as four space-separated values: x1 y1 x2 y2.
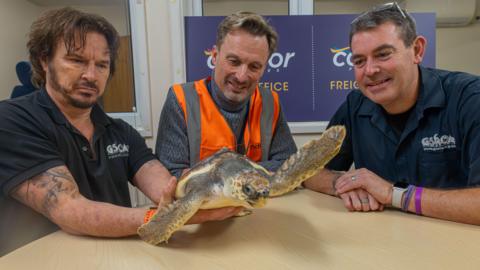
0 8 239 255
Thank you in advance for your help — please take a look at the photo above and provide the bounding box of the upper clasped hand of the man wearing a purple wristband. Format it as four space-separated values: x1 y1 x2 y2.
335 168 392 204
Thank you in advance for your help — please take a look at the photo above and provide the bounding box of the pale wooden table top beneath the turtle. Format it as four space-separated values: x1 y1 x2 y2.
0 190 480 270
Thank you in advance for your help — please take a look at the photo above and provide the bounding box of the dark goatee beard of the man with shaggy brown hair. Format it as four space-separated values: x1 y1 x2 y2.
48 63 98 109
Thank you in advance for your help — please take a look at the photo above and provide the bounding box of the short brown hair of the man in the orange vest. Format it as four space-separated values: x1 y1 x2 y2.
216 11 278 55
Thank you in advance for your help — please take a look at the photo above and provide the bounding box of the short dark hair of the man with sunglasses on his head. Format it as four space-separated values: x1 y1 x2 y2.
350 2 417 47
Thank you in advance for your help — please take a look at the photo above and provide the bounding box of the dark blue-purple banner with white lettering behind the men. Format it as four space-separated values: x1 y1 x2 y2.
185 13 435 122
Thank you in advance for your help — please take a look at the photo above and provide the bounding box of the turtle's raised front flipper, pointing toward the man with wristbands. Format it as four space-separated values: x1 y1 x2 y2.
270 126 346 197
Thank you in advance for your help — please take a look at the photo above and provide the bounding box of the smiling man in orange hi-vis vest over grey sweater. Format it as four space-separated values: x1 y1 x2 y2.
156 12 296 177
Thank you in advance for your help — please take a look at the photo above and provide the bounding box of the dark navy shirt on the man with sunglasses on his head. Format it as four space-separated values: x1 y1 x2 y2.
327 67 480 188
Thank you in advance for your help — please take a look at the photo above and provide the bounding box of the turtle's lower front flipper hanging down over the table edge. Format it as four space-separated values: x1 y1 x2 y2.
137 193 206 245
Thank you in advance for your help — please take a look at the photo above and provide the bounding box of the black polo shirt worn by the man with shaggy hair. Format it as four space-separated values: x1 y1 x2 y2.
0 90 155 206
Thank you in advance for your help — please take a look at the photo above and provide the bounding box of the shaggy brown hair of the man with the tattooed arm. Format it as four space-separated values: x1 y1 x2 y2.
27 7 119 87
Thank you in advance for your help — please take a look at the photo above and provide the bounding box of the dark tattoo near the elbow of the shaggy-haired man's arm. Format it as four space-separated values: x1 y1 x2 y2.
14 167 79 217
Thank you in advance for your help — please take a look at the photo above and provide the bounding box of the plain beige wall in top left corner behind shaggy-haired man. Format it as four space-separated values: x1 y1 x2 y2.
0 0 40 100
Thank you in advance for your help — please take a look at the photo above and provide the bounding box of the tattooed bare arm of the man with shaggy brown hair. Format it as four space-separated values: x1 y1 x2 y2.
11 166 145 237
